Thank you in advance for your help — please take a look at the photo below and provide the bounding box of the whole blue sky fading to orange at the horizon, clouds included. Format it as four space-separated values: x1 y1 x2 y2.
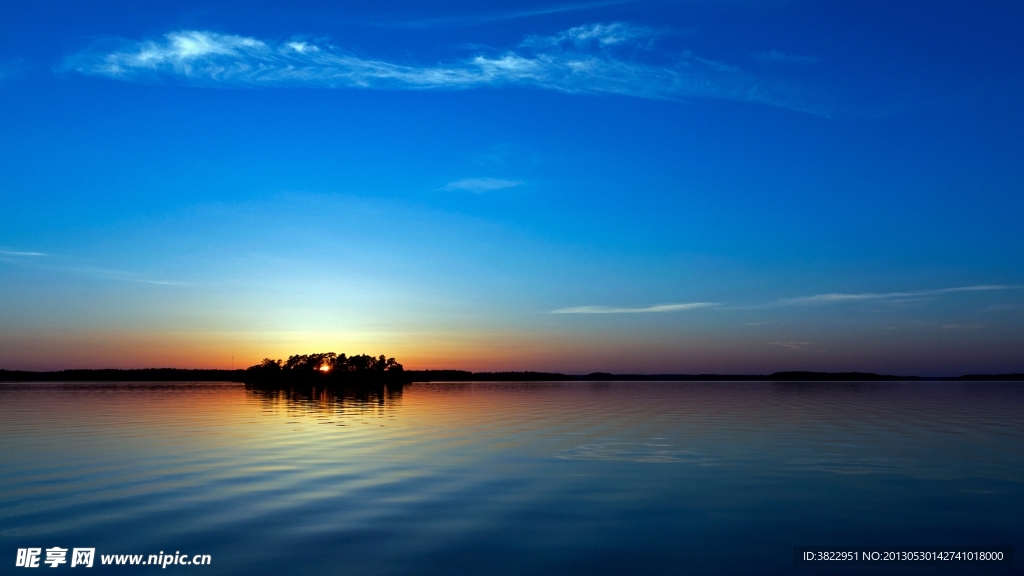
0 0 1024 375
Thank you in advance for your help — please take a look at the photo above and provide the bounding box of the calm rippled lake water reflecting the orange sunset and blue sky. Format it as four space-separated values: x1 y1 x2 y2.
0 382 1024 575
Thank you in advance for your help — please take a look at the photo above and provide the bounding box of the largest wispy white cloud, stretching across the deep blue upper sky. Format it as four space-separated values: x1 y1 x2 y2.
66 23 822 114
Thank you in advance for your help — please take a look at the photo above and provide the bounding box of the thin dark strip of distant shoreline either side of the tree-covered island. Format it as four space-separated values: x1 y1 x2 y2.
0 368 1024 382
